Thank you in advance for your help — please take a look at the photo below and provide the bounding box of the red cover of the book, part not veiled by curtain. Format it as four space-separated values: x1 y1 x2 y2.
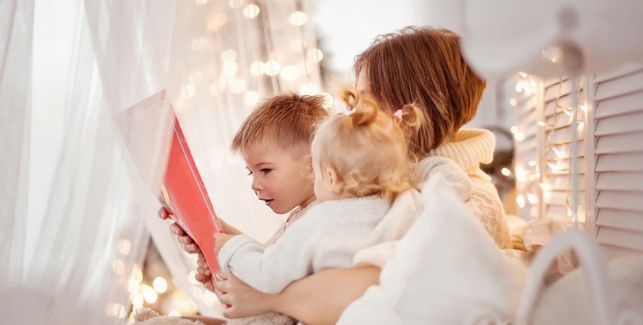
162 111 223 273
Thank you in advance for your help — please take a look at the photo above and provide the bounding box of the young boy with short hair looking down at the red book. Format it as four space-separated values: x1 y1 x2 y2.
160 94 328 274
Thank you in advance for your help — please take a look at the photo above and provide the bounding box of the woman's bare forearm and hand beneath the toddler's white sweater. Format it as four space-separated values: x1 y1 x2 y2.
217 267 381 324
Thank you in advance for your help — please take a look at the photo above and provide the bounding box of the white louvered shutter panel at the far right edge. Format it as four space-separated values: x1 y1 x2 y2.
588 67 643 257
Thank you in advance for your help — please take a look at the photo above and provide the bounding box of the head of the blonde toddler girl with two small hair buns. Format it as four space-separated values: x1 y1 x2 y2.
312 90 422 201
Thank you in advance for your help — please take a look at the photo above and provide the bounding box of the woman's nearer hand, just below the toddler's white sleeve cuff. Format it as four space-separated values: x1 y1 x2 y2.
214 272 278 318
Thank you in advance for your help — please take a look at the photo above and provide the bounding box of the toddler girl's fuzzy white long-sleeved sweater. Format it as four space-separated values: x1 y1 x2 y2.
218 190 421 293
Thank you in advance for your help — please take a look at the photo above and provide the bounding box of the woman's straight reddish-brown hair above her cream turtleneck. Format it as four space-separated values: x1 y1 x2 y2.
354 27 486 159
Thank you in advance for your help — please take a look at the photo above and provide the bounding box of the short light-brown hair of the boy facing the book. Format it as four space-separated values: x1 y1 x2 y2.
232 94 328 154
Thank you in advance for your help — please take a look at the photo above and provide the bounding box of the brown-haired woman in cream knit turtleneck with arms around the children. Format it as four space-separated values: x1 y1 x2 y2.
167 28 510 324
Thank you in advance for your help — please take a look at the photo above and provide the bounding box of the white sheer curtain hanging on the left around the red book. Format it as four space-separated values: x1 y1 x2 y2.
0 0 319 324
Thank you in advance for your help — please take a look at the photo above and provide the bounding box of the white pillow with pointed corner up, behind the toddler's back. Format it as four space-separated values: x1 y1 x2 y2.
338 175 524 324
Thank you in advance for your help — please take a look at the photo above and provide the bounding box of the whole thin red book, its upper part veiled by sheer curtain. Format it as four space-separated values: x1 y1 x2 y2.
117 90 223 273
